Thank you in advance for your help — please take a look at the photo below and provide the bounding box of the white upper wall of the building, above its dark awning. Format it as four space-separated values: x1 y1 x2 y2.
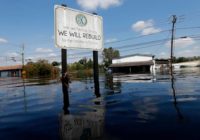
112 56 152 64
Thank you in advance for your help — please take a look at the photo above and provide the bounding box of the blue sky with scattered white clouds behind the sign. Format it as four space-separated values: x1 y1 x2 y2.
0 0 200 65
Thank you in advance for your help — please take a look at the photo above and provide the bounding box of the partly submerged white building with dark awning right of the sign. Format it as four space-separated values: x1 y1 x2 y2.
110 54 155 73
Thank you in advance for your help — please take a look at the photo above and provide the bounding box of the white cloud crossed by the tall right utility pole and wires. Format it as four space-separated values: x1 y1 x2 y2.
166 37 195 48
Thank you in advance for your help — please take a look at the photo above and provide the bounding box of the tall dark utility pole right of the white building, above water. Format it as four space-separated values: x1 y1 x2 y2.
170 15 177 69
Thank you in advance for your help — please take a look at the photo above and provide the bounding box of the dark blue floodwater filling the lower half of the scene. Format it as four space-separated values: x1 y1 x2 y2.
0 68 200 140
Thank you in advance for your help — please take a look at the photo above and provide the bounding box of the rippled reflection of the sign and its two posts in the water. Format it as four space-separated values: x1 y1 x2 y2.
59 81 105 140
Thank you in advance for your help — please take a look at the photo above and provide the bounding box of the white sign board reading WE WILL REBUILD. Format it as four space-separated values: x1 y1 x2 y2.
54 5 103 50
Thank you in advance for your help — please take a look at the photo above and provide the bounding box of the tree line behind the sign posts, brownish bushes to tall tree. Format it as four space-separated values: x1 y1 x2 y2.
23 47 120 77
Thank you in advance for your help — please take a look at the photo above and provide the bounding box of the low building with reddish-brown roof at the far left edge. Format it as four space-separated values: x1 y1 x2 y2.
0 65 22 77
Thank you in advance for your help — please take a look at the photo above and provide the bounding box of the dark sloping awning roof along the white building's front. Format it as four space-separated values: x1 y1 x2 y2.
110 61 153 68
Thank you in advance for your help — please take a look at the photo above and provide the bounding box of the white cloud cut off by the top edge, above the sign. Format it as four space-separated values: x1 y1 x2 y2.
76 0 122 11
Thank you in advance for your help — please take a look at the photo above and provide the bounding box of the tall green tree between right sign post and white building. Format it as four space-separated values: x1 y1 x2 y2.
102 47 120 70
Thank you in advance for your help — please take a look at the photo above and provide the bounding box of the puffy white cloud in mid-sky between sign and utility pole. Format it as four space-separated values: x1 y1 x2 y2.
132 19 161 35
